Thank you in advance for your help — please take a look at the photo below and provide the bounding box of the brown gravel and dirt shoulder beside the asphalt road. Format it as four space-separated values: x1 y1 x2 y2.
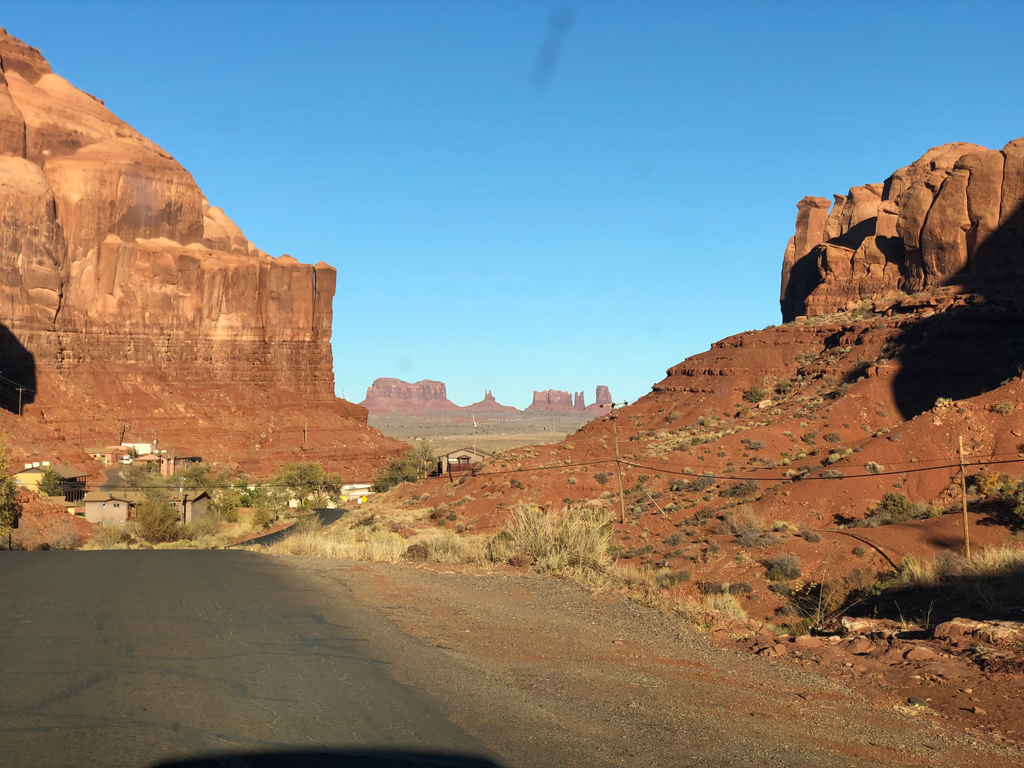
274 557 1024 768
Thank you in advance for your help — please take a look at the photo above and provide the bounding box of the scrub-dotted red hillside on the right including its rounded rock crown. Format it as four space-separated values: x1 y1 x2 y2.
376 142 1024 618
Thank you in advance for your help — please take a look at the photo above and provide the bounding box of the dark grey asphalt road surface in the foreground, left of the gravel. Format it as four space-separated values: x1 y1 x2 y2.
0 551 498 768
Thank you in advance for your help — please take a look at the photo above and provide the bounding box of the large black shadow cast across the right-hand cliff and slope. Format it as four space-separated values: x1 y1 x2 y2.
893 195 1024 419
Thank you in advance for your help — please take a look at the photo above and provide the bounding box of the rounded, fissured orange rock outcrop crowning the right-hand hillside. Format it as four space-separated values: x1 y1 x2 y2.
780 139 1024 322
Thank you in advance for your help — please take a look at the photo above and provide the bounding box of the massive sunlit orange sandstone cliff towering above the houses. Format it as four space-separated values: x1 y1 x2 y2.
0 30 397 481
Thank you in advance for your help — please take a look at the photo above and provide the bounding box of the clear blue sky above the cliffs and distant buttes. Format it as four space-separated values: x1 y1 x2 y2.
8 0 1024 407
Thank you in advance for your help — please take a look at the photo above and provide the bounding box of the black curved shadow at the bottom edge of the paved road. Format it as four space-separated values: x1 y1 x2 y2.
153 750 501 768
